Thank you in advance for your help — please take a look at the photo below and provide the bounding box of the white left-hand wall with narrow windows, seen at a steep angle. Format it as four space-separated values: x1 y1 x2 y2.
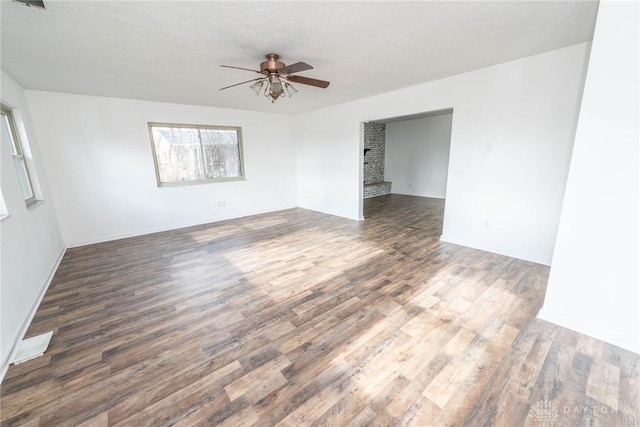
0 72 64 378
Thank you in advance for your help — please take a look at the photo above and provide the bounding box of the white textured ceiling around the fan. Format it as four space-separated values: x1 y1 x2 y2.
1 0 597 113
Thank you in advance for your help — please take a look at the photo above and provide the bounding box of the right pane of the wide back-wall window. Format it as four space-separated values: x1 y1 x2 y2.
200 129 242 179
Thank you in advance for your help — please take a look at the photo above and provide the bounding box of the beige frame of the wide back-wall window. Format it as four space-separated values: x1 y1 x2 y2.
148 122 246 187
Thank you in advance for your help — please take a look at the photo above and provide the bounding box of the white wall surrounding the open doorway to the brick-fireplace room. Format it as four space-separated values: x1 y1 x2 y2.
297 43 588 264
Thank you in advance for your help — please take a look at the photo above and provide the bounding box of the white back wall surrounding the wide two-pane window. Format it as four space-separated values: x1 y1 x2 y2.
26 91 296 246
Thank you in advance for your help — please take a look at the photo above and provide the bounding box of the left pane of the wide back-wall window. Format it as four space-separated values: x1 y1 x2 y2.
153 127 203 182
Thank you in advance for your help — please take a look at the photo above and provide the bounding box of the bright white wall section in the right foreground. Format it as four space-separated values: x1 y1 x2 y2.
540 0 640 353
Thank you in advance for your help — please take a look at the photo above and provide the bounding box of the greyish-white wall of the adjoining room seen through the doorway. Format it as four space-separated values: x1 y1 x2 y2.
384 113 453 199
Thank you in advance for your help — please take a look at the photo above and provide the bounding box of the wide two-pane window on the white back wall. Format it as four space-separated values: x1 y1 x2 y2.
149 123 244 186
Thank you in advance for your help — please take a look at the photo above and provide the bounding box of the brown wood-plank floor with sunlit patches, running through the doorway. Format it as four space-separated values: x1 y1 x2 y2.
0 195 640 426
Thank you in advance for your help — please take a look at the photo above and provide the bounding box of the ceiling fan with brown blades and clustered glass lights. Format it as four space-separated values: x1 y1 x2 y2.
220 53 329 103
